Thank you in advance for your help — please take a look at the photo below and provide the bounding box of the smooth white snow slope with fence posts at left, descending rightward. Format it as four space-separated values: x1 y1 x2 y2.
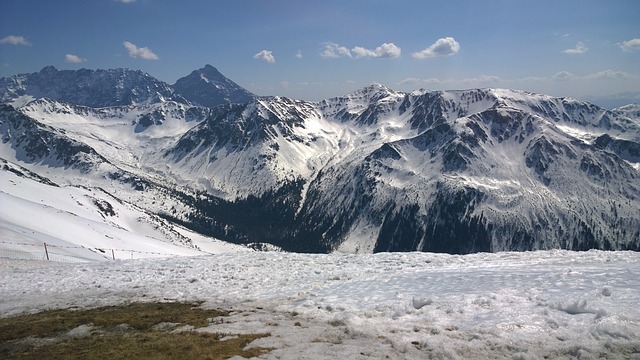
0 160 248 261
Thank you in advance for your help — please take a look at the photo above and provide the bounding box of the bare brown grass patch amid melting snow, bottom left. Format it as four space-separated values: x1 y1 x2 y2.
0 303 271 359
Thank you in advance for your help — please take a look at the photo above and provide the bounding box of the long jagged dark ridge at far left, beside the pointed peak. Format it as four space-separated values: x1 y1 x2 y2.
0 66 186 108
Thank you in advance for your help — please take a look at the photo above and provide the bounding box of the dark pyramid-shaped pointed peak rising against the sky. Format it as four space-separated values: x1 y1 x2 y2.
173 65 256 107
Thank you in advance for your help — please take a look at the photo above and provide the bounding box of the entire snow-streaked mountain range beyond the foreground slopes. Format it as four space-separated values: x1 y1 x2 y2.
0 65 640 253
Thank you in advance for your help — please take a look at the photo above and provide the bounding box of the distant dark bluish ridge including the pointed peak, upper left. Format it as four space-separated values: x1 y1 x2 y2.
0 65 255 108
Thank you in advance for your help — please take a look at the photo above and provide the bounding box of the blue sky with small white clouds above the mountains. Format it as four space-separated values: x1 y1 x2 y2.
0 0 640 107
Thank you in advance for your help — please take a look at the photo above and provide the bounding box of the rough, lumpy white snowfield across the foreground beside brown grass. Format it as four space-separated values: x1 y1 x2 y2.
0 251 640 359
